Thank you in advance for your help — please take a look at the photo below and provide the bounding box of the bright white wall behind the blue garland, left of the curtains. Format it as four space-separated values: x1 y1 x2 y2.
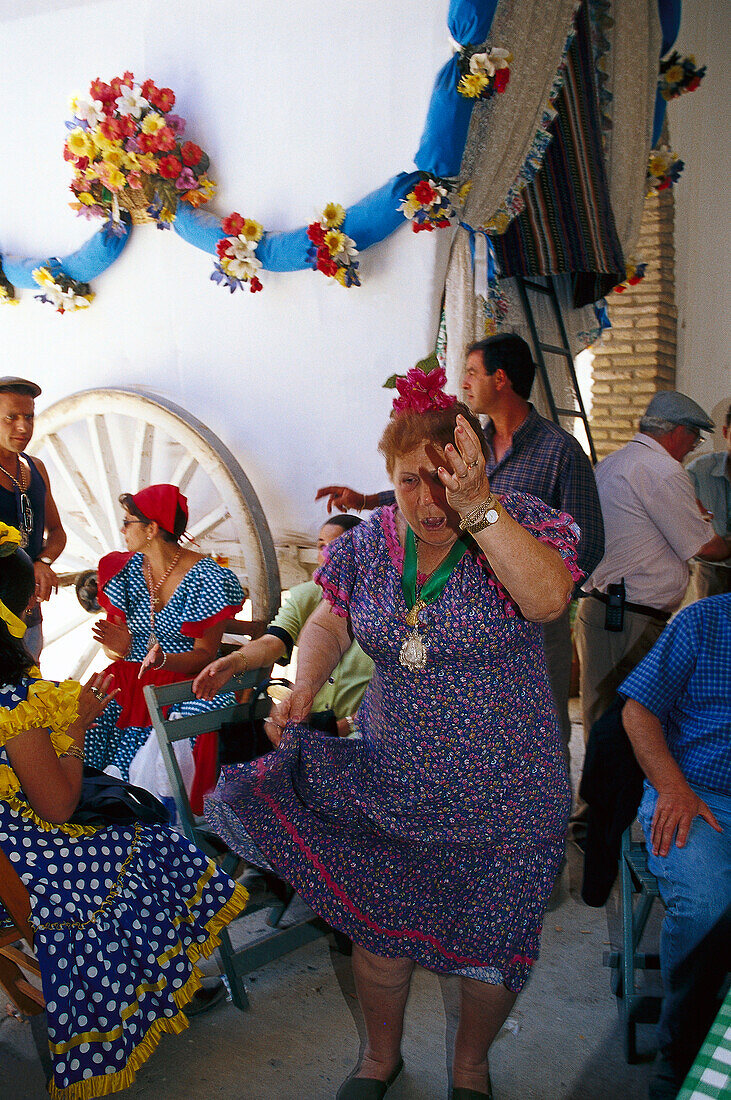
0 0 450 537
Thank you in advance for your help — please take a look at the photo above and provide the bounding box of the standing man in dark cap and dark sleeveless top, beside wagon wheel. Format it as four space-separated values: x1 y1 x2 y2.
0 376 66 659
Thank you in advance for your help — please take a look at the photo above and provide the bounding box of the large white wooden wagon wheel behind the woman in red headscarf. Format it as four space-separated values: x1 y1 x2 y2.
30 389 280 679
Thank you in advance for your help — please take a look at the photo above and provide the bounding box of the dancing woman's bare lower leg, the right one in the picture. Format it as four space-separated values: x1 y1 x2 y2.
452 978 518 1095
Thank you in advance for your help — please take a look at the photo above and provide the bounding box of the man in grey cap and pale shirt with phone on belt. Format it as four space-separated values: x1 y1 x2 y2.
572 391 731 844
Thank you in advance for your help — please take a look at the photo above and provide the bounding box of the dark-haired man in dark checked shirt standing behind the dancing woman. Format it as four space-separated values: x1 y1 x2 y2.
315 333 605 766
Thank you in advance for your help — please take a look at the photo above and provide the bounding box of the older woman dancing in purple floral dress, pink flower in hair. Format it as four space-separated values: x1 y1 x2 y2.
207 371 579 1100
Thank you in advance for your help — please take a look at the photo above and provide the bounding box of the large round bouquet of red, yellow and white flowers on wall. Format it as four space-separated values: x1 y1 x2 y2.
64 73 215 233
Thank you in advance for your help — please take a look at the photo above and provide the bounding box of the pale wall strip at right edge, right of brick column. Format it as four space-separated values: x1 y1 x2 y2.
668 0 731 437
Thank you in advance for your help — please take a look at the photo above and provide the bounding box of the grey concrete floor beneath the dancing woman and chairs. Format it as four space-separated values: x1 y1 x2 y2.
0 704 656 1100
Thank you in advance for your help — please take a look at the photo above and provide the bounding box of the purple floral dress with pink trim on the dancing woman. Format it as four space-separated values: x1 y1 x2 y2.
206 493 580 990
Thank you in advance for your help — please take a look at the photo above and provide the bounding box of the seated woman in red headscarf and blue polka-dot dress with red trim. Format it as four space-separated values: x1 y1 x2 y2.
86 485 244 796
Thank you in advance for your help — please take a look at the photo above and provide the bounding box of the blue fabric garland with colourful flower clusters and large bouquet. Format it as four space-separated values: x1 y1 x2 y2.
0 0 705 312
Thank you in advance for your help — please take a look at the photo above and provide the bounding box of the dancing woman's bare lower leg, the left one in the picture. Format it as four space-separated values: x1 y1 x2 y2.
353 944 413 1081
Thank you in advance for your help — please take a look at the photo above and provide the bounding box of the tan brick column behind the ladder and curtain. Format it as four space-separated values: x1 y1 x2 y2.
590 190 677 459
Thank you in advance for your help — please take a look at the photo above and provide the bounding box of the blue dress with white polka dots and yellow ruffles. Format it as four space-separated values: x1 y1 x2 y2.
0 674 247 1100
